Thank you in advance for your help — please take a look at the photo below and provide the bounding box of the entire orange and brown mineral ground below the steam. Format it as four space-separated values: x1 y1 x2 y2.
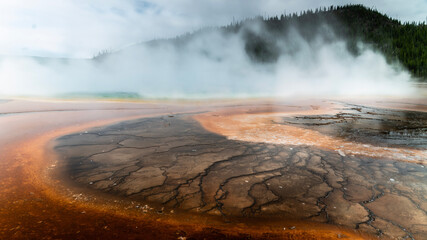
0 100 427 239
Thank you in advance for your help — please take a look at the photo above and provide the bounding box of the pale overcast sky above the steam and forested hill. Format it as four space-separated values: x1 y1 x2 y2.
0 0 427 58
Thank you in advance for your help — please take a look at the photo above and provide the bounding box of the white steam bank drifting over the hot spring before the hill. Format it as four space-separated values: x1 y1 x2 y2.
0 22 414 99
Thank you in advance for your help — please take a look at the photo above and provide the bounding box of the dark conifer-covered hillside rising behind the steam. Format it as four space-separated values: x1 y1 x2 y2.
95 5 427 82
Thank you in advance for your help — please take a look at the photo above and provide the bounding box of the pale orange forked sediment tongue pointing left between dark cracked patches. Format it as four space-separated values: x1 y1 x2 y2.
194 101 427 164
